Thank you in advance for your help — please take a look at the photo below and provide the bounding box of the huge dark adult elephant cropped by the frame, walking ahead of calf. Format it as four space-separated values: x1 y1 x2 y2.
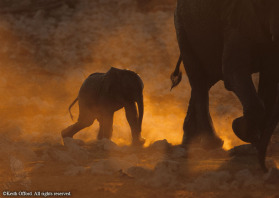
171 0 279 169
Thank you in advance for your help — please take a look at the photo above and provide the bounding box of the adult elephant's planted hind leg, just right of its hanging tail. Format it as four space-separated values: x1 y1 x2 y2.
176 24 223 148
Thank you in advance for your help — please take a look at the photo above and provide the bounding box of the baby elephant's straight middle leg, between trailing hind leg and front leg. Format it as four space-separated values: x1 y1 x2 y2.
97 111 114 140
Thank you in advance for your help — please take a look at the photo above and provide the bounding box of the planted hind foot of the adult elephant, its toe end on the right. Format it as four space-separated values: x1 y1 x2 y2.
201 134 224 150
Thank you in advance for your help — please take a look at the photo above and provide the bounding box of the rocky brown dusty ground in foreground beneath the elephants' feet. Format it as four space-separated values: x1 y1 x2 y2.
0 139 279 198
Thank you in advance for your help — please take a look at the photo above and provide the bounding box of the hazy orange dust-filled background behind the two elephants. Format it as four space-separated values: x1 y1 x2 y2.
0 0 245 148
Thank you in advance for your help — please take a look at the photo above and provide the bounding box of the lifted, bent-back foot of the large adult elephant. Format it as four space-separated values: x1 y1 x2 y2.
232 117 260 146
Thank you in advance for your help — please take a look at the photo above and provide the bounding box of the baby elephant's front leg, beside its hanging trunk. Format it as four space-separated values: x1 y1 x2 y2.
125 102 145 145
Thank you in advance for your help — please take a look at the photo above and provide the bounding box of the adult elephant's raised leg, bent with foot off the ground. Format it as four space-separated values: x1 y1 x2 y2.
223 29 264 144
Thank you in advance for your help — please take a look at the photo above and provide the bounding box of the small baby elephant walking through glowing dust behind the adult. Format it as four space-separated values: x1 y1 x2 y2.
61 67 145 145
